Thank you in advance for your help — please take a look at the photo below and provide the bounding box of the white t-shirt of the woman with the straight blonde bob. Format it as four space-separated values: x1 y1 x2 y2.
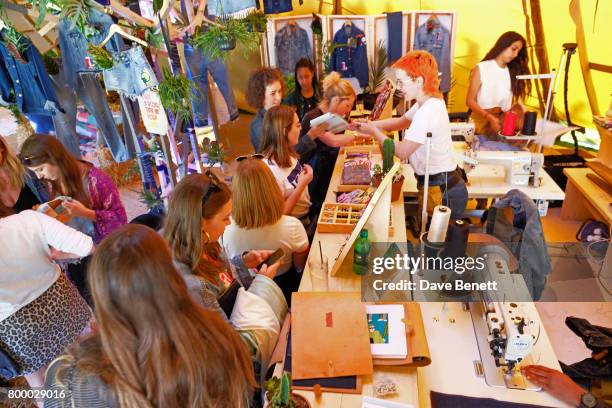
223 215 308 276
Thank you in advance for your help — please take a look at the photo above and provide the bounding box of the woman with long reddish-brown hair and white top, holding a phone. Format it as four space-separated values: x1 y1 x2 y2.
261 105 313 222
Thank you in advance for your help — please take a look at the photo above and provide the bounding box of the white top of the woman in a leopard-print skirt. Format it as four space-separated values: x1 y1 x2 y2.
0 210 93 321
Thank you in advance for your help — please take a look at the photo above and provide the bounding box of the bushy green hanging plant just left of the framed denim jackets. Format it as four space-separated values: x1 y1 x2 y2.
191 19 259 60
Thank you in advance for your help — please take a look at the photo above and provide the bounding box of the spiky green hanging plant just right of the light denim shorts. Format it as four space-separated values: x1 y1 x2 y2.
159 69 198 120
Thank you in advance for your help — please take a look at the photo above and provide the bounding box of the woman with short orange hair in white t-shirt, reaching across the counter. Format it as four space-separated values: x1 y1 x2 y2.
353 51 467 219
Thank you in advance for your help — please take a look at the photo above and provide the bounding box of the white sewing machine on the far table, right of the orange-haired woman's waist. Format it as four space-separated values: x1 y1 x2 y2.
462 149 544 187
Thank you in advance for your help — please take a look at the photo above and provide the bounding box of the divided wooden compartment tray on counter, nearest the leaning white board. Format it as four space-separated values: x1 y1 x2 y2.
317 203 394 237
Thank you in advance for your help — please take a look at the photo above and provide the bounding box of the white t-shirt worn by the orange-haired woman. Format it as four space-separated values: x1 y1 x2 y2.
400 98 457 176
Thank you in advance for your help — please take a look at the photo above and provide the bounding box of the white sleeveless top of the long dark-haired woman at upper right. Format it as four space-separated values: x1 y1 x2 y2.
476 59 512 112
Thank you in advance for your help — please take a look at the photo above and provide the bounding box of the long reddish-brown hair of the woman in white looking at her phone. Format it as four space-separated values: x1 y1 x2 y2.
259 105 297 168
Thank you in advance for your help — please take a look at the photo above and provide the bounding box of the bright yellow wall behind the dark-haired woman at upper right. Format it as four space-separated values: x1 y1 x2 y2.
274 0 612 131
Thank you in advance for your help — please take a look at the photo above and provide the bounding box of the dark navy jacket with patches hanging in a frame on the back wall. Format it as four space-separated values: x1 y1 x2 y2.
329 24 368 87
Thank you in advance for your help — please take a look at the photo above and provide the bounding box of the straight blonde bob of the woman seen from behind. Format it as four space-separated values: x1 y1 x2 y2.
232 158 285 229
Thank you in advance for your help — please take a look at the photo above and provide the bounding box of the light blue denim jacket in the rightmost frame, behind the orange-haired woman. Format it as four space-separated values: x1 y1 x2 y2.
414 22 451 92
